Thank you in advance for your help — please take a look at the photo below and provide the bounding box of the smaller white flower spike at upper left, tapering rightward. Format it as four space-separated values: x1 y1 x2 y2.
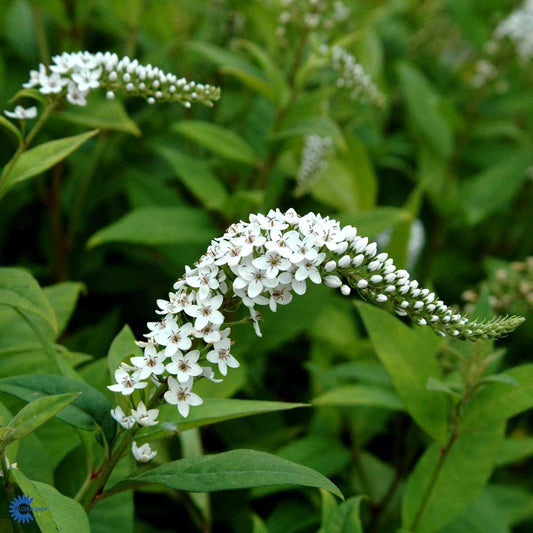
23 52 220 107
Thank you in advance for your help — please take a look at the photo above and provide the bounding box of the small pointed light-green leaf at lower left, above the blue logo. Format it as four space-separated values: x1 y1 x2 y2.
6 392 81 443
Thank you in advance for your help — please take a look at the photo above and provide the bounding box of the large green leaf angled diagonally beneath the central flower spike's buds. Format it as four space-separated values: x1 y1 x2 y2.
356 302 448 444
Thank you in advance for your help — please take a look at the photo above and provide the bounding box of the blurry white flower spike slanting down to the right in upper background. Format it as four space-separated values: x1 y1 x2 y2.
323 46 385 107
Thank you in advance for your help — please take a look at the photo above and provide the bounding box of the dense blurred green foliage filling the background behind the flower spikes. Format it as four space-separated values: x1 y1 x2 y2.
0 0 533 533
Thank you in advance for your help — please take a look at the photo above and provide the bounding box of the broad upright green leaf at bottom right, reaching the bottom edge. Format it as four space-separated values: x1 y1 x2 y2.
402 423 505 533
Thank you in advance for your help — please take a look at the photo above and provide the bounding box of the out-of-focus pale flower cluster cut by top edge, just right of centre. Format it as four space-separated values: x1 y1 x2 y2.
277 0 351 37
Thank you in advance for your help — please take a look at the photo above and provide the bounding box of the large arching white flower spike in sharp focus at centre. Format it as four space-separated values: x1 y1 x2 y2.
109 209 523 461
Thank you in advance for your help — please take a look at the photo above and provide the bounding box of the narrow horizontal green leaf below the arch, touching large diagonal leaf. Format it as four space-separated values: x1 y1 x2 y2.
311 385 405 411
